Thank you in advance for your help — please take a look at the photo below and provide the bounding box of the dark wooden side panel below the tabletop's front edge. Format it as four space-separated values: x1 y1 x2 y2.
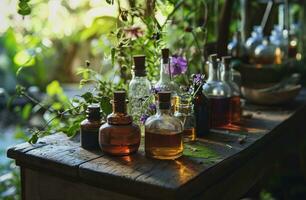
23 169 137 200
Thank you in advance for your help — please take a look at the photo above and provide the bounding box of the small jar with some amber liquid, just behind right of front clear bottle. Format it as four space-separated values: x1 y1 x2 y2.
174 98 196 142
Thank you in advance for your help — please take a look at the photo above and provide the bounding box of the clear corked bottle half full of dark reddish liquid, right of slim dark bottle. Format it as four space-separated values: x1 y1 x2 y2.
202 54 231 128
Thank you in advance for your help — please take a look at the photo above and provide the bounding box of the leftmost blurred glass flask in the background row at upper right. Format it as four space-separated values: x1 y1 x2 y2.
227 31 247 59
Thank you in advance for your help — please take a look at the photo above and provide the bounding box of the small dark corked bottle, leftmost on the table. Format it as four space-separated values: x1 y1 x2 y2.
80 104 104 150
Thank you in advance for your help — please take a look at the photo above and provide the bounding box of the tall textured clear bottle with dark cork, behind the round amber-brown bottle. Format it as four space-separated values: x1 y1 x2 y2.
129 55 151 124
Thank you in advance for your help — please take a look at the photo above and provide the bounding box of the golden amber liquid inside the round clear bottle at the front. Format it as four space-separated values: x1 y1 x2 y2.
145 130 183 160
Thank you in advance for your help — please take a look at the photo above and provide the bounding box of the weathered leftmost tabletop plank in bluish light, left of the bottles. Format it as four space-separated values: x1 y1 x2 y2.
13 136 103 178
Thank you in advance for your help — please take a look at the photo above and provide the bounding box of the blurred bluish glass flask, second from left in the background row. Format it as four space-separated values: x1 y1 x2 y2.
245 26 263 62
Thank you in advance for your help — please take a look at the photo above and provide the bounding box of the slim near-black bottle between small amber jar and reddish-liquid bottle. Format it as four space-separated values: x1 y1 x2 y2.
193 79 210 137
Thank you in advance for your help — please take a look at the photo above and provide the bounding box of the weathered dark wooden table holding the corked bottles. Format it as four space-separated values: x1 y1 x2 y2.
7 91 306 200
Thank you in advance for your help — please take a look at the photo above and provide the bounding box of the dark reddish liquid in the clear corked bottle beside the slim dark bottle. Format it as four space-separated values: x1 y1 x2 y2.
208 98 231 128
